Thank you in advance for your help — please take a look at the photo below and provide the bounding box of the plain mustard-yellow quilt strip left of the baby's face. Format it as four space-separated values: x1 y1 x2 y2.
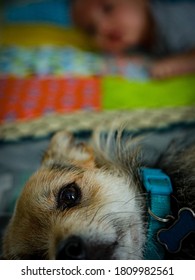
0 24 93 50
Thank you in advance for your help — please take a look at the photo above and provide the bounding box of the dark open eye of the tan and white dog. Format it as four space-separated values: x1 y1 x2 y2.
57 183 81 211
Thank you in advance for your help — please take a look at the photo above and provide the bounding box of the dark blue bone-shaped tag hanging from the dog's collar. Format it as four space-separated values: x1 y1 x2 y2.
158 208 195 253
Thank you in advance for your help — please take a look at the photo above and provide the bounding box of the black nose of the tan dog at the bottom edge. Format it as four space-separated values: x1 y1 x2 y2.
56 236 86 260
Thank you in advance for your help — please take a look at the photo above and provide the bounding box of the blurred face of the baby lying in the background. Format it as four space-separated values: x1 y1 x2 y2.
73 0 147 53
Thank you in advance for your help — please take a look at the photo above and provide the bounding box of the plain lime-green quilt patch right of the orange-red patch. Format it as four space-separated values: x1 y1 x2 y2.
102 76 195 109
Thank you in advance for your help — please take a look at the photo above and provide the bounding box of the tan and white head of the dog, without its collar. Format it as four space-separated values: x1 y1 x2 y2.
3 132 145 259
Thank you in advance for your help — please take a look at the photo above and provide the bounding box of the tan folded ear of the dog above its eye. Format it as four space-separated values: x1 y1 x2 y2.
42 131 95 167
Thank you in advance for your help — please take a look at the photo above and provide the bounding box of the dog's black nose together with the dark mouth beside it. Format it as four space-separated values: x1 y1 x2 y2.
56 236 118 260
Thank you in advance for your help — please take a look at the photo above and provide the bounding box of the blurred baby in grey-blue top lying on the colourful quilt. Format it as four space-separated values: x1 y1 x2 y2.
71 0 195 78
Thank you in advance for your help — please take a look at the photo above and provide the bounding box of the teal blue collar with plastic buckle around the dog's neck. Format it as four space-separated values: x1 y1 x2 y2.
140 168 173 260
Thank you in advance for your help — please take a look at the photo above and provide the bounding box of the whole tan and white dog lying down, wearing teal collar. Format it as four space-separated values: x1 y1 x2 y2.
3 129 195 260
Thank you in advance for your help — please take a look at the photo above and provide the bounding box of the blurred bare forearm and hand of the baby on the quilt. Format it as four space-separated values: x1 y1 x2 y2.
149 49 195 79
